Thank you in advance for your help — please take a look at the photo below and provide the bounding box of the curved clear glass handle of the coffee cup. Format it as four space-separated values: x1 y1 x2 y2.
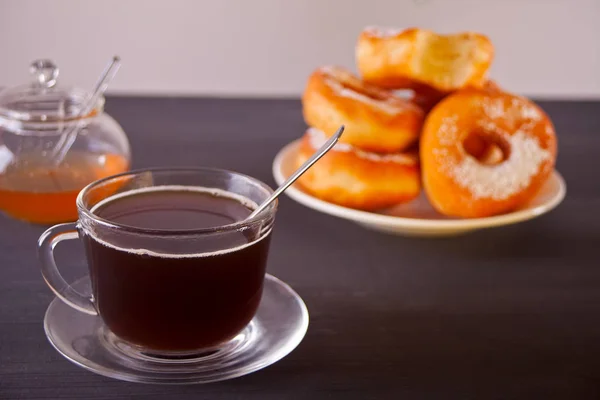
38 222 98 315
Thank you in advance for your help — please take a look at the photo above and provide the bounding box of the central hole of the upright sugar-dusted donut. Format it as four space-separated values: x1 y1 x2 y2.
462 131 510 165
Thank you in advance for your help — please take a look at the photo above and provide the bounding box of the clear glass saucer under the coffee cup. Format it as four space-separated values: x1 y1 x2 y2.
44 275 308 384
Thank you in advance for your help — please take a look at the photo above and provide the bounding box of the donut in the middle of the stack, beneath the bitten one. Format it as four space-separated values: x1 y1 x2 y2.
302 67 424 153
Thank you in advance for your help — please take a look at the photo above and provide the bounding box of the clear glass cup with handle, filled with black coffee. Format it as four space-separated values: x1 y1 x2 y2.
39 168 276 353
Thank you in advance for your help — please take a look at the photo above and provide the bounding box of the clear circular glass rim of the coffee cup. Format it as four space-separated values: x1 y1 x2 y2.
76 167 278 237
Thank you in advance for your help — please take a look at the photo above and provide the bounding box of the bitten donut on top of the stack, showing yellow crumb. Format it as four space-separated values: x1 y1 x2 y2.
356 28 494 93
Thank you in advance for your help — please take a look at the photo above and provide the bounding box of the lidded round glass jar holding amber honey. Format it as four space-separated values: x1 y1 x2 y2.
0 60 131 224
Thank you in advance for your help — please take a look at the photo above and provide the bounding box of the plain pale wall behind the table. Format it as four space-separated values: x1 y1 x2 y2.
0 0 600 98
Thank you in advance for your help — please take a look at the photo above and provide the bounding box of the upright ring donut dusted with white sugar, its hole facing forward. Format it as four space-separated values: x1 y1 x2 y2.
420 89 557 218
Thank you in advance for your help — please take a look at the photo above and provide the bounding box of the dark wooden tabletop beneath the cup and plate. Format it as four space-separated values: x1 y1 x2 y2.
0 98 600 400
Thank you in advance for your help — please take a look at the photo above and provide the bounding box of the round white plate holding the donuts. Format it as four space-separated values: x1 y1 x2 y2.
273 140 567 236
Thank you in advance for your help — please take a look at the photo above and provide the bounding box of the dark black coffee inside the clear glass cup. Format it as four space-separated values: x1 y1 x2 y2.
80 186 270 351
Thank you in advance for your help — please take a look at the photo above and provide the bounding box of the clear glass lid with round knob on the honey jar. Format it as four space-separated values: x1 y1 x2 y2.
0 59 104 122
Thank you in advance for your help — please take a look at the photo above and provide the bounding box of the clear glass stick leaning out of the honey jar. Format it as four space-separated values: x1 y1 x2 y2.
50 56 121 165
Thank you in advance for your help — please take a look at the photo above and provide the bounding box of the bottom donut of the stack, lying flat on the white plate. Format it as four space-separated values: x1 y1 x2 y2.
296 128 421 211
